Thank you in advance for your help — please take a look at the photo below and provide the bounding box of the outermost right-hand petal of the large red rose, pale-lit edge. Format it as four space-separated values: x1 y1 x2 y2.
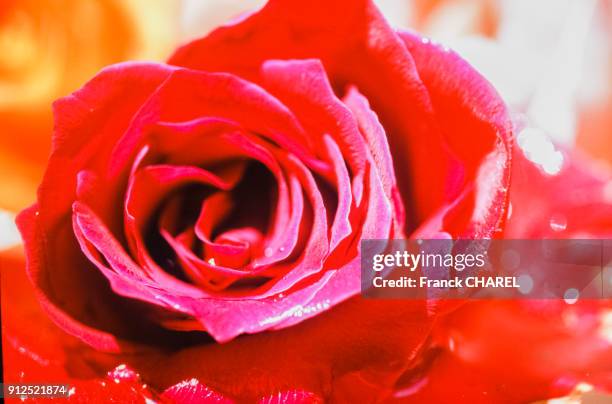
400 32 513 238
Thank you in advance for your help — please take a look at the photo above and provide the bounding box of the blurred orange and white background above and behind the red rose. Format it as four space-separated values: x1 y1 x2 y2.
0 0 612 248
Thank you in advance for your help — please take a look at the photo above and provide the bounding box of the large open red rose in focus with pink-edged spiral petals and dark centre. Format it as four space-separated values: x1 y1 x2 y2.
19 1 510 351
